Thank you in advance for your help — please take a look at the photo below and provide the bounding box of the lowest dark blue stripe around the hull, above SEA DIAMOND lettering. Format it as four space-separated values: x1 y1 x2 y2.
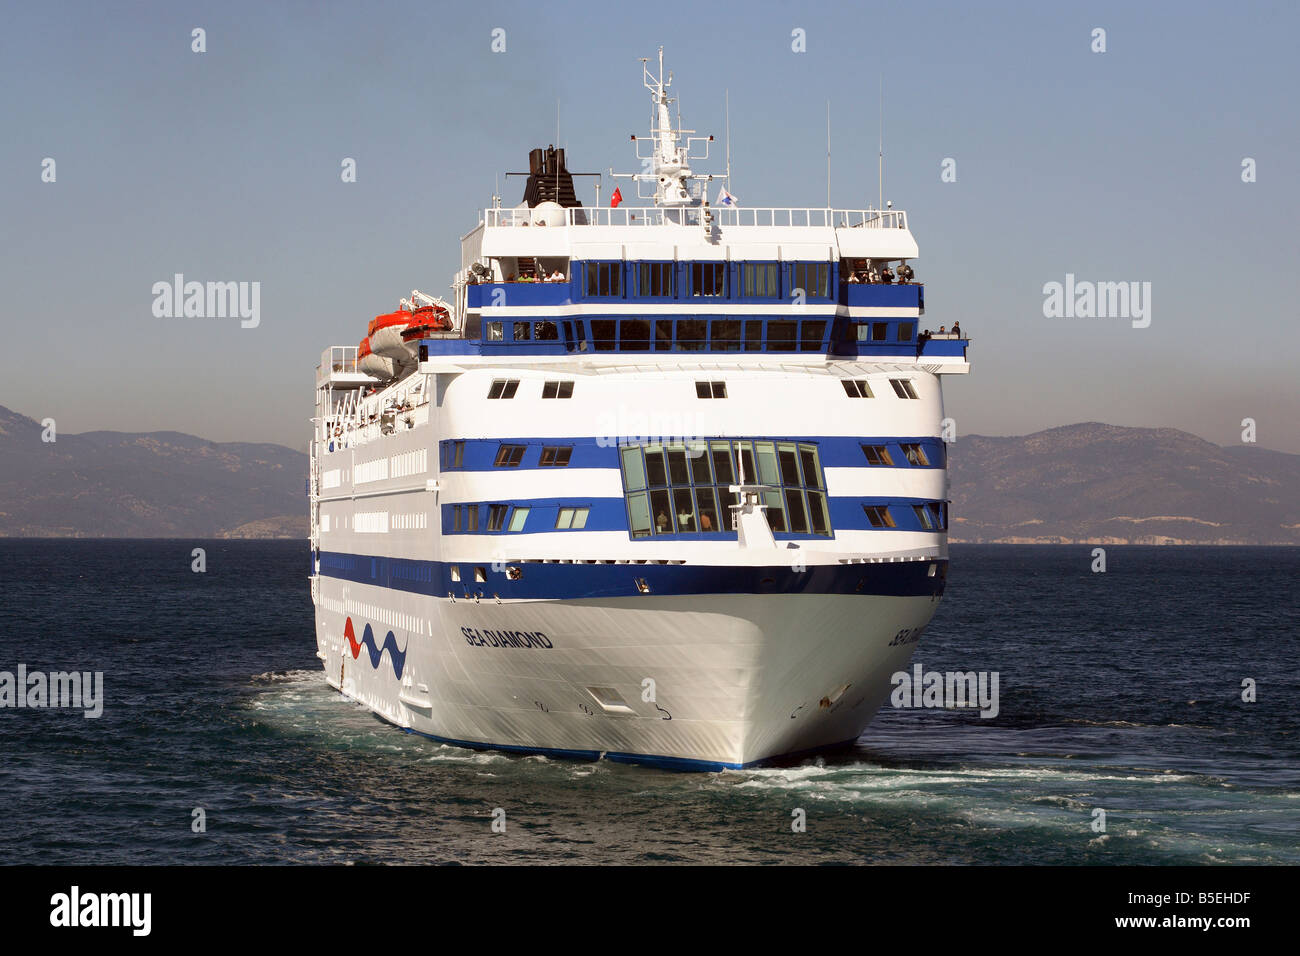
320 551 948 601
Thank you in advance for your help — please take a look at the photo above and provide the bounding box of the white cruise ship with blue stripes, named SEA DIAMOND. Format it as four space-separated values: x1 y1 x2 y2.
308 51 969 770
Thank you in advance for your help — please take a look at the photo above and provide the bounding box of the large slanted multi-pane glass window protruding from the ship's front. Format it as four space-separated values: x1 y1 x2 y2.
620 440 831 537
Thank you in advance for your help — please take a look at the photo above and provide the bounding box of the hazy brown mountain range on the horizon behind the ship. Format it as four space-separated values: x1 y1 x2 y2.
0 406 1300 545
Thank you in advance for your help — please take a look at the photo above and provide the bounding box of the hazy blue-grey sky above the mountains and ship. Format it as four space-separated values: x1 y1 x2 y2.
0 3 1300 453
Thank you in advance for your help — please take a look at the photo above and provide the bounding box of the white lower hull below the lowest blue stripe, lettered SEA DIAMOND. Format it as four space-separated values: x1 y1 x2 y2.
317 581 937 769
